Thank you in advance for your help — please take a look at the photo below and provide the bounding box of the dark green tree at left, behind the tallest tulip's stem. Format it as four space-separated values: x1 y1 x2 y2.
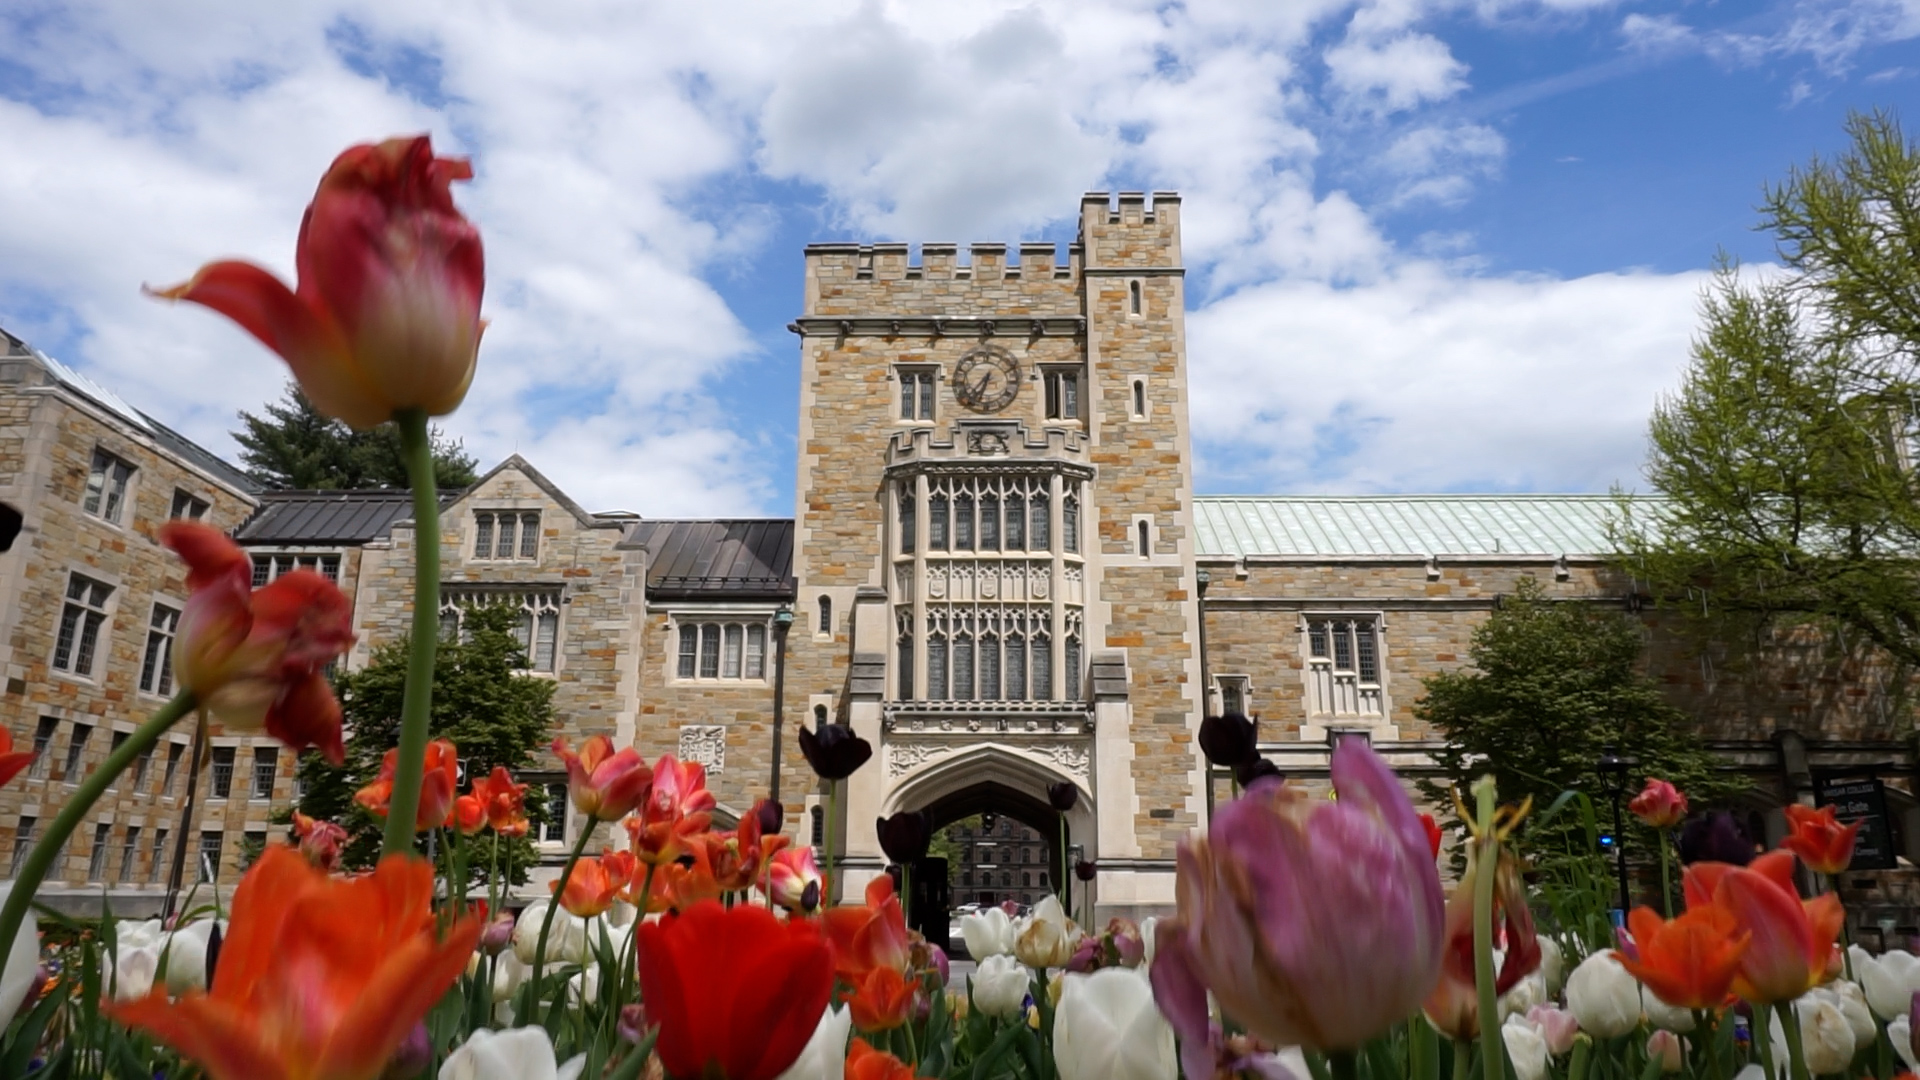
284 605 559 884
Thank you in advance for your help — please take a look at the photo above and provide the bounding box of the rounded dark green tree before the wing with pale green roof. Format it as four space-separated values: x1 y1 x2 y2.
1413 578 1738 861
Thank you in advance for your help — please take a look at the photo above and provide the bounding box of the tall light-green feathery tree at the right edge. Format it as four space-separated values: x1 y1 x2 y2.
1619 113 1920 682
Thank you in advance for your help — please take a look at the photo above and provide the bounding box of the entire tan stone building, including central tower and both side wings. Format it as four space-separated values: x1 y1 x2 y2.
0 192 1920 926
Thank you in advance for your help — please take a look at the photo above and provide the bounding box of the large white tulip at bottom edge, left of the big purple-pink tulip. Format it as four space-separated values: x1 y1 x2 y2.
1054 967 1181 1080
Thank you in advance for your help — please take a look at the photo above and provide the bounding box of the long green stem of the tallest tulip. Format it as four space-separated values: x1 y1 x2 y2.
380 409 440 857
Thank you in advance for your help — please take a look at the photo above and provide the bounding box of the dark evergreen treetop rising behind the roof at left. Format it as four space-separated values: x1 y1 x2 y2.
234 382 478 490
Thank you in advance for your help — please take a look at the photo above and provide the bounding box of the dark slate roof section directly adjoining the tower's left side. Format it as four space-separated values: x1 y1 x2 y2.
622 517 793 600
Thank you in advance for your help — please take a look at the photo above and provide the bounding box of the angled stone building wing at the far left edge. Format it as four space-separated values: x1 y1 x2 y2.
0 332 294 913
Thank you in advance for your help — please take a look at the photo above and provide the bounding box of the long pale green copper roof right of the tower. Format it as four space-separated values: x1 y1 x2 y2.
1194 496 1643 559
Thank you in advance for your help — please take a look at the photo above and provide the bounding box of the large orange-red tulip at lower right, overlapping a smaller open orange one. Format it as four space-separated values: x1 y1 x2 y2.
1682 851 1845 1005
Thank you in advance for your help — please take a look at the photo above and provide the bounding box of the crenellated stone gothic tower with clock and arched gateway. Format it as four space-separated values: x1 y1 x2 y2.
785 192 1204 915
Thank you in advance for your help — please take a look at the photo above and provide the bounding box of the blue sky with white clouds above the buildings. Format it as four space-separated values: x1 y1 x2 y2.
0 0 1920 515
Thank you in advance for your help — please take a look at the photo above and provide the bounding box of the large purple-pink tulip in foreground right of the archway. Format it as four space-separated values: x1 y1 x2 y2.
1152 740 1444 1053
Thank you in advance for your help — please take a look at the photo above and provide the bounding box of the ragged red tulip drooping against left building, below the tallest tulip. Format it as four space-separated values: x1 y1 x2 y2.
159 521 353 765
